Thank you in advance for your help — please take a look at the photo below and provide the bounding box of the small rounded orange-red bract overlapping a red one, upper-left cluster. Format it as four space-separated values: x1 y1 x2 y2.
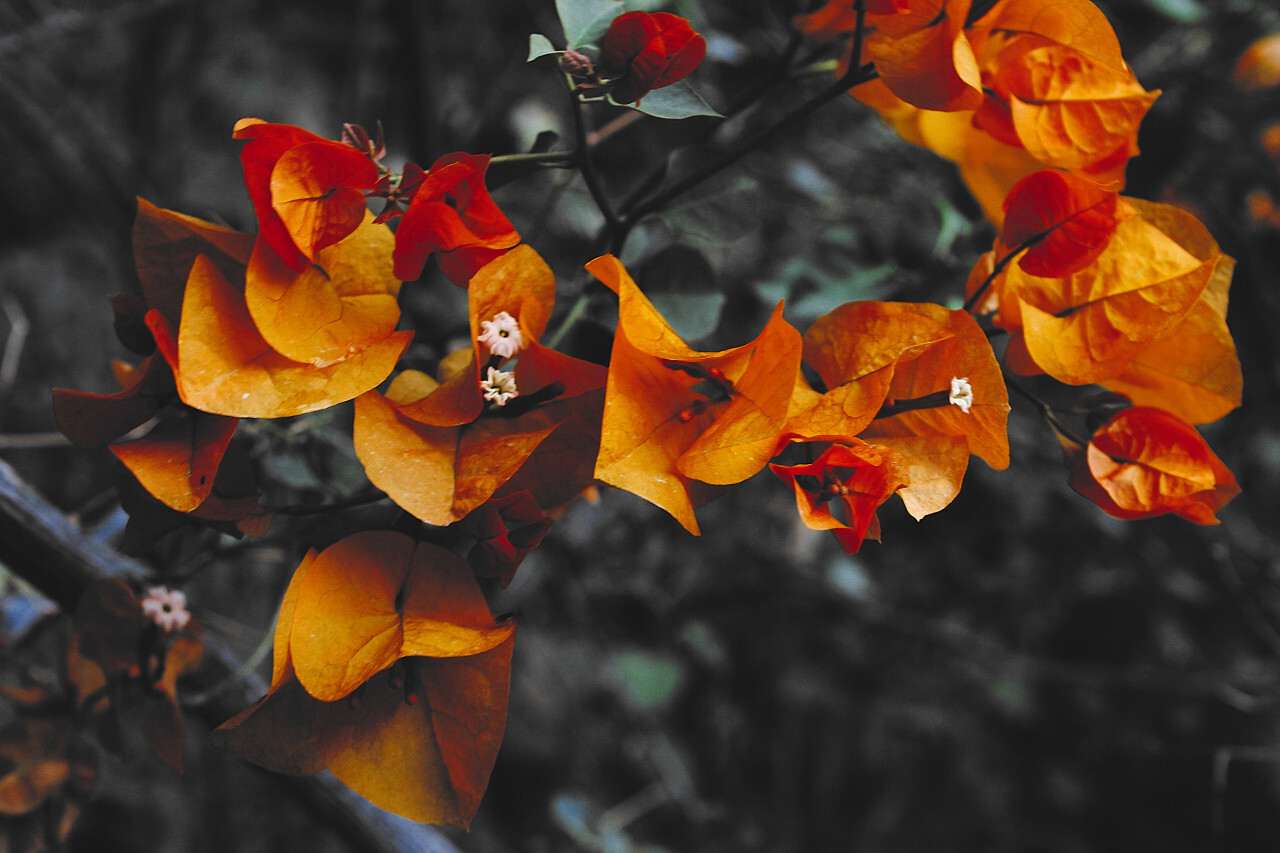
270 140 378 263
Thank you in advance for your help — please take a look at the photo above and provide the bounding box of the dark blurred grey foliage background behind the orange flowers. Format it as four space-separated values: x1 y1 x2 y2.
0 0 1280 853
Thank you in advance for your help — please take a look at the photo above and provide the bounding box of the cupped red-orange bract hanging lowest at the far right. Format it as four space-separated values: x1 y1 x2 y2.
1070 406 1240 524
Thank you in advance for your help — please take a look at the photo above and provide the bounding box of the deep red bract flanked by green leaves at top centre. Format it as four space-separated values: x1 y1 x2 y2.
596 12 707 104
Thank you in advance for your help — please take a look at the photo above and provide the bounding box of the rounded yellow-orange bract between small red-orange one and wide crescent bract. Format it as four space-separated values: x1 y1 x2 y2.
244 208 399 368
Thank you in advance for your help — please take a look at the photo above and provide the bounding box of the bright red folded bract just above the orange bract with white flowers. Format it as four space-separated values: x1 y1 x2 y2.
393 152 520 287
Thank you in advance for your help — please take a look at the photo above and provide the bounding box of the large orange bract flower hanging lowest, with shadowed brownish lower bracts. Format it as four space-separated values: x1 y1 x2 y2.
215 532 513 827
